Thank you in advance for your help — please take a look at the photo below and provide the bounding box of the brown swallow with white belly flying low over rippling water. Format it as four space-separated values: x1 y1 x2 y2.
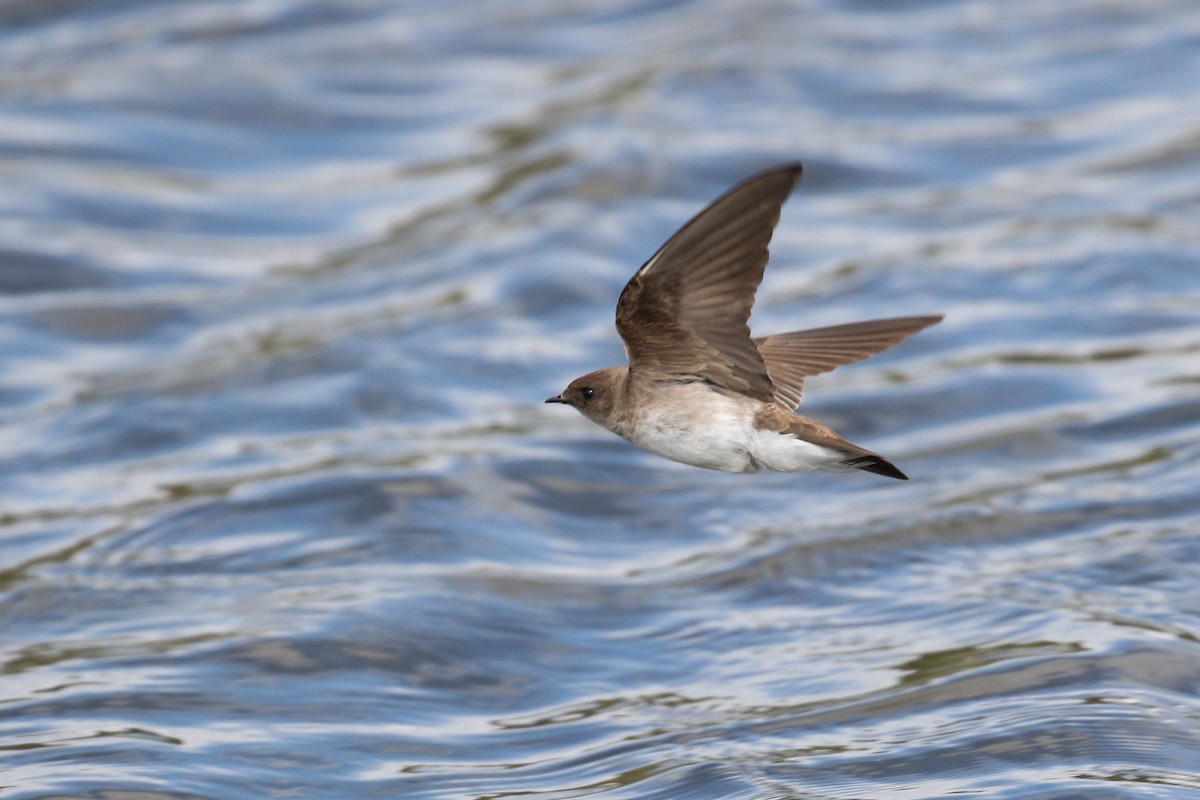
546 163 942 480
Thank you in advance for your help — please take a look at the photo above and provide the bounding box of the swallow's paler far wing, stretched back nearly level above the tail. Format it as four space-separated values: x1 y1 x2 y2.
754 315 942 409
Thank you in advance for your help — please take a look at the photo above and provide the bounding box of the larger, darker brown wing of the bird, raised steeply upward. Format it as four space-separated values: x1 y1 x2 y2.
617 164 800 402
